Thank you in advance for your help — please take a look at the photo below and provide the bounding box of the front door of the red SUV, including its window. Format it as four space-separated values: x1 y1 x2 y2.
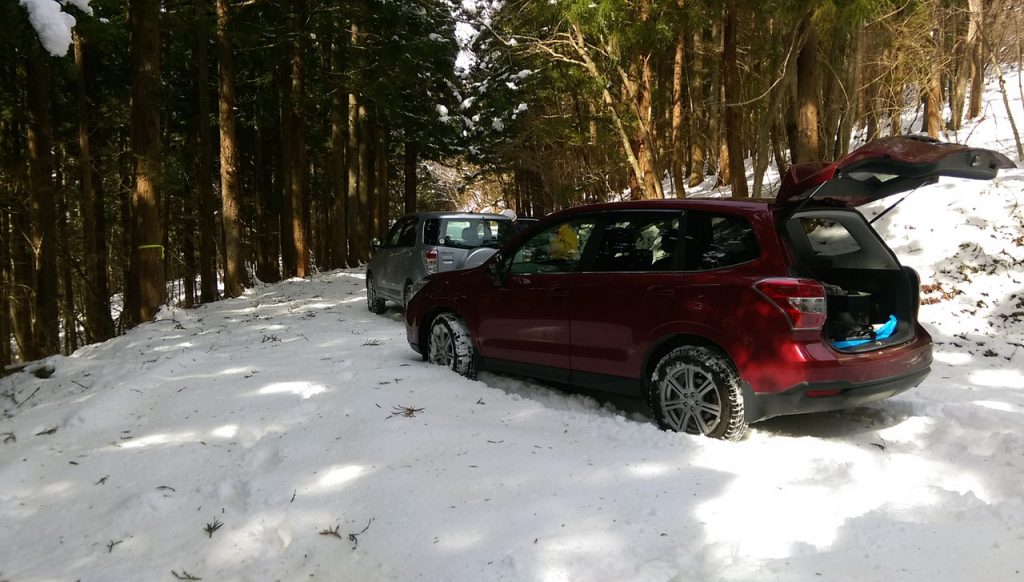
477 217 595 382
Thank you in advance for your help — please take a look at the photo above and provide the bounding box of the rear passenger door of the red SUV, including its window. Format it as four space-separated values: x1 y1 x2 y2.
569 210 683 392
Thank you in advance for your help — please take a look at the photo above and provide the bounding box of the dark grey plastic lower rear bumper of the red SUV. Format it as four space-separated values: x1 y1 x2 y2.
742 367 931 422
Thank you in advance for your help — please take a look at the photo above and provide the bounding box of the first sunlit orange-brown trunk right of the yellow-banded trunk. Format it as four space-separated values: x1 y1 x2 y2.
217 0 249 297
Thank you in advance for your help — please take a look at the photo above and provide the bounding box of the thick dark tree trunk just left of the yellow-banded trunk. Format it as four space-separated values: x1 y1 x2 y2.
75 32 114 343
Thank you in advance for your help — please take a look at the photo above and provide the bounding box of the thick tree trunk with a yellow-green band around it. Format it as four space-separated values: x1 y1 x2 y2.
129 0 167 322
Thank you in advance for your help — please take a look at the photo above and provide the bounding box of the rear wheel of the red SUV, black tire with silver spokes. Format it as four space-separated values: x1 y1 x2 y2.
647 345 746 441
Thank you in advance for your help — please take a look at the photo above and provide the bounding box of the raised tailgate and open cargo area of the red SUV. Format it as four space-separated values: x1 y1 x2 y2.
774 136 1015 351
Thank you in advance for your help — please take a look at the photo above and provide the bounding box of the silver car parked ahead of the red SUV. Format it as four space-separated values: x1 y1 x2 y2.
367 212 515 314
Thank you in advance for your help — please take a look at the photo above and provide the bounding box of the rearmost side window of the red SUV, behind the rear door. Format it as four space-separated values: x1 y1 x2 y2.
683 212 761 271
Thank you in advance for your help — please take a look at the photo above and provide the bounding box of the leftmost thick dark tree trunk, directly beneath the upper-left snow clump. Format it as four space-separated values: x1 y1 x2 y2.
28 41 60 358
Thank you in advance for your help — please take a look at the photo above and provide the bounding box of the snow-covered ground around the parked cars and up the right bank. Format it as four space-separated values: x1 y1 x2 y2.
0 80 1024 582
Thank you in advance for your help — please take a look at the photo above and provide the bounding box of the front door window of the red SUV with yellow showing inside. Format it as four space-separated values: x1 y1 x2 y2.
508 218 595 274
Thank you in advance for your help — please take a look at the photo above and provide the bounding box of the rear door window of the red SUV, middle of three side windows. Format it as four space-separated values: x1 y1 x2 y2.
591 212 680 272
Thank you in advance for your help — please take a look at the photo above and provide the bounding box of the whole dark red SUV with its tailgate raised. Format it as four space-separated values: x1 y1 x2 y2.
407 137 1013 440
